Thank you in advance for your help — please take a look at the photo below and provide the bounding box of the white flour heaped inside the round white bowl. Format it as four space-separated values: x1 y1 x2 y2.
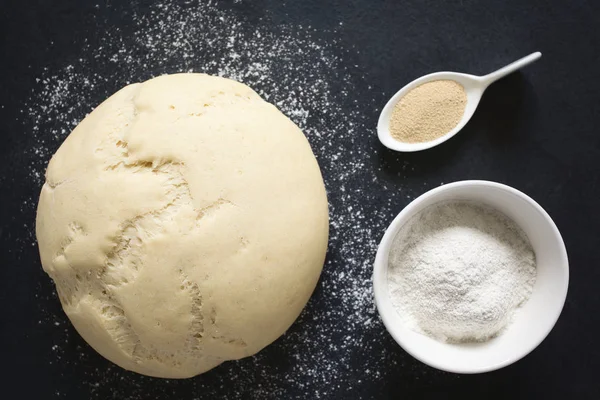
388 202 536 342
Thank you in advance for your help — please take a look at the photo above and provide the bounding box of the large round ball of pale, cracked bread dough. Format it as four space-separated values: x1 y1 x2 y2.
36 74 328 378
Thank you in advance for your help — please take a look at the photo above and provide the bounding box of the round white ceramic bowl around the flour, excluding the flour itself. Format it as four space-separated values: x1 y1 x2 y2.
373 181 569 373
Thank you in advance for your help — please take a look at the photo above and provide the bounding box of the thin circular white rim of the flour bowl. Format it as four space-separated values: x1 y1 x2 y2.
373 180 569 374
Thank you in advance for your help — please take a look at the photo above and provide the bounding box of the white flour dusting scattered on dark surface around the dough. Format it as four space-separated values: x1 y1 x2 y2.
19 1 432 400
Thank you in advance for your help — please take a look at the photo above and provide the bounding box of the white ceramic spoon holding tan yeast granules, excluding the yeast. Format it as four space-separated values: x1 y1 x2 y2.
377 51 542 152
